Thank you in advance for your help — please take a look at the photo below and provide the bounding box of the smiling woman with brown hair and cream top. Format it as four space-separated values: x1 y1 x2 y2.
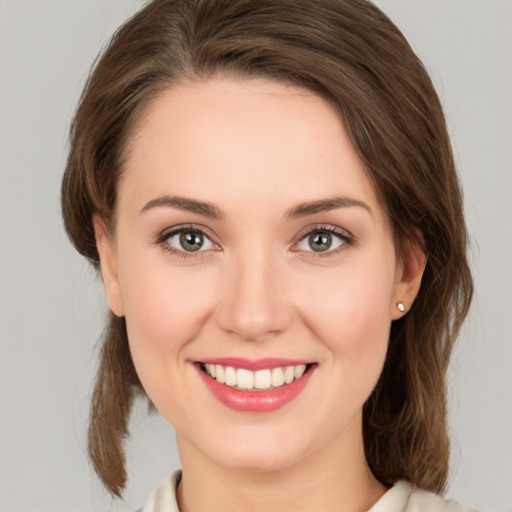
62 0 472 512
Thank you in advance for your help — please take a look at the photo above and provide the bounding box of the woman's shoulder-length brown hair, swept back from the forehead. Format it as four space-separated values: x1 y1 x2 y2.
62 0 473 496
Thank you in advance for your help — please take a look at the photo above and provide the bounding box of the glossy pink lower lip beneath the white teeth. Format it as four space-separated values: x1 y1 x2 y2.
196 365 315 412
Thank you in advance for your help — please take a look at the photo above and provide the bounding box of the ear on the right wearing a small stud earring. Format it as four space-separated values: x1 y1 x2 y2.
390 237 427 320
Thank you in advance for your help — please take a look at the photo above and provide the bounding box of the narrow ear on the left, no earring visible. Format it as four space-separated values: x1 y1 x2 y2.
93 215 124 316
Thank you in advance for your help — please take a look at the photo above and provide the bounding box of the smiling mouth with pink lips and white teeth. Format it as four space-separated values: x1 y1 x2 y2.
195 359 318 412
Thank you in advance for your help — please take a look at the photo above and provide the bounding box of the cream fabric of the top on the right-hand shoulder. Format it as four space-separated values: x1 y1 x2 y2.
368 480 477 512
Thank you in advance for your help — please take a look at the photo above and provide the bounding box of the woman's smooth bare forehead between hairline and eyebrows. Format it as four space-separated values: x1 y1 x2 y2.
119 78 382 217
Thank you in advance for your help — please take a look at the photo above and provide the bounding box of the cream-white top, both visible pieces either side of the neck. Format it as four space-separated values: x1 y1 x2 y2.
140 470 476 512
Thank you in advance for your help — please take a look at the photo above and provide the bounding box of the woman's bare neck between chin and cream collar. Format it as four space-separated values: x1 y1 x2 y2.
177 416 387 512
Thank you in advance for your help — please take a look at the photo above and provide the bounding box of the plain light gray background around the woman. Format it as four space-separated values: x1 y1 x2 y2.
0 0 512 512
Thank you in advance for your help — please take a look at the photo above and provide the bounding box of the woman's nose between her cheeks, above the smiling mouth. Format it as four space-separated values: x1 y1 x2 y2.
217 247 292 341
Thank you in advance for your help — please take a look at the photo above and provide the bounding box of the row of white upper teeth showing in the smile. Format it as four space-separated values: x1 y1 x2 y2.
204 364 306 390
